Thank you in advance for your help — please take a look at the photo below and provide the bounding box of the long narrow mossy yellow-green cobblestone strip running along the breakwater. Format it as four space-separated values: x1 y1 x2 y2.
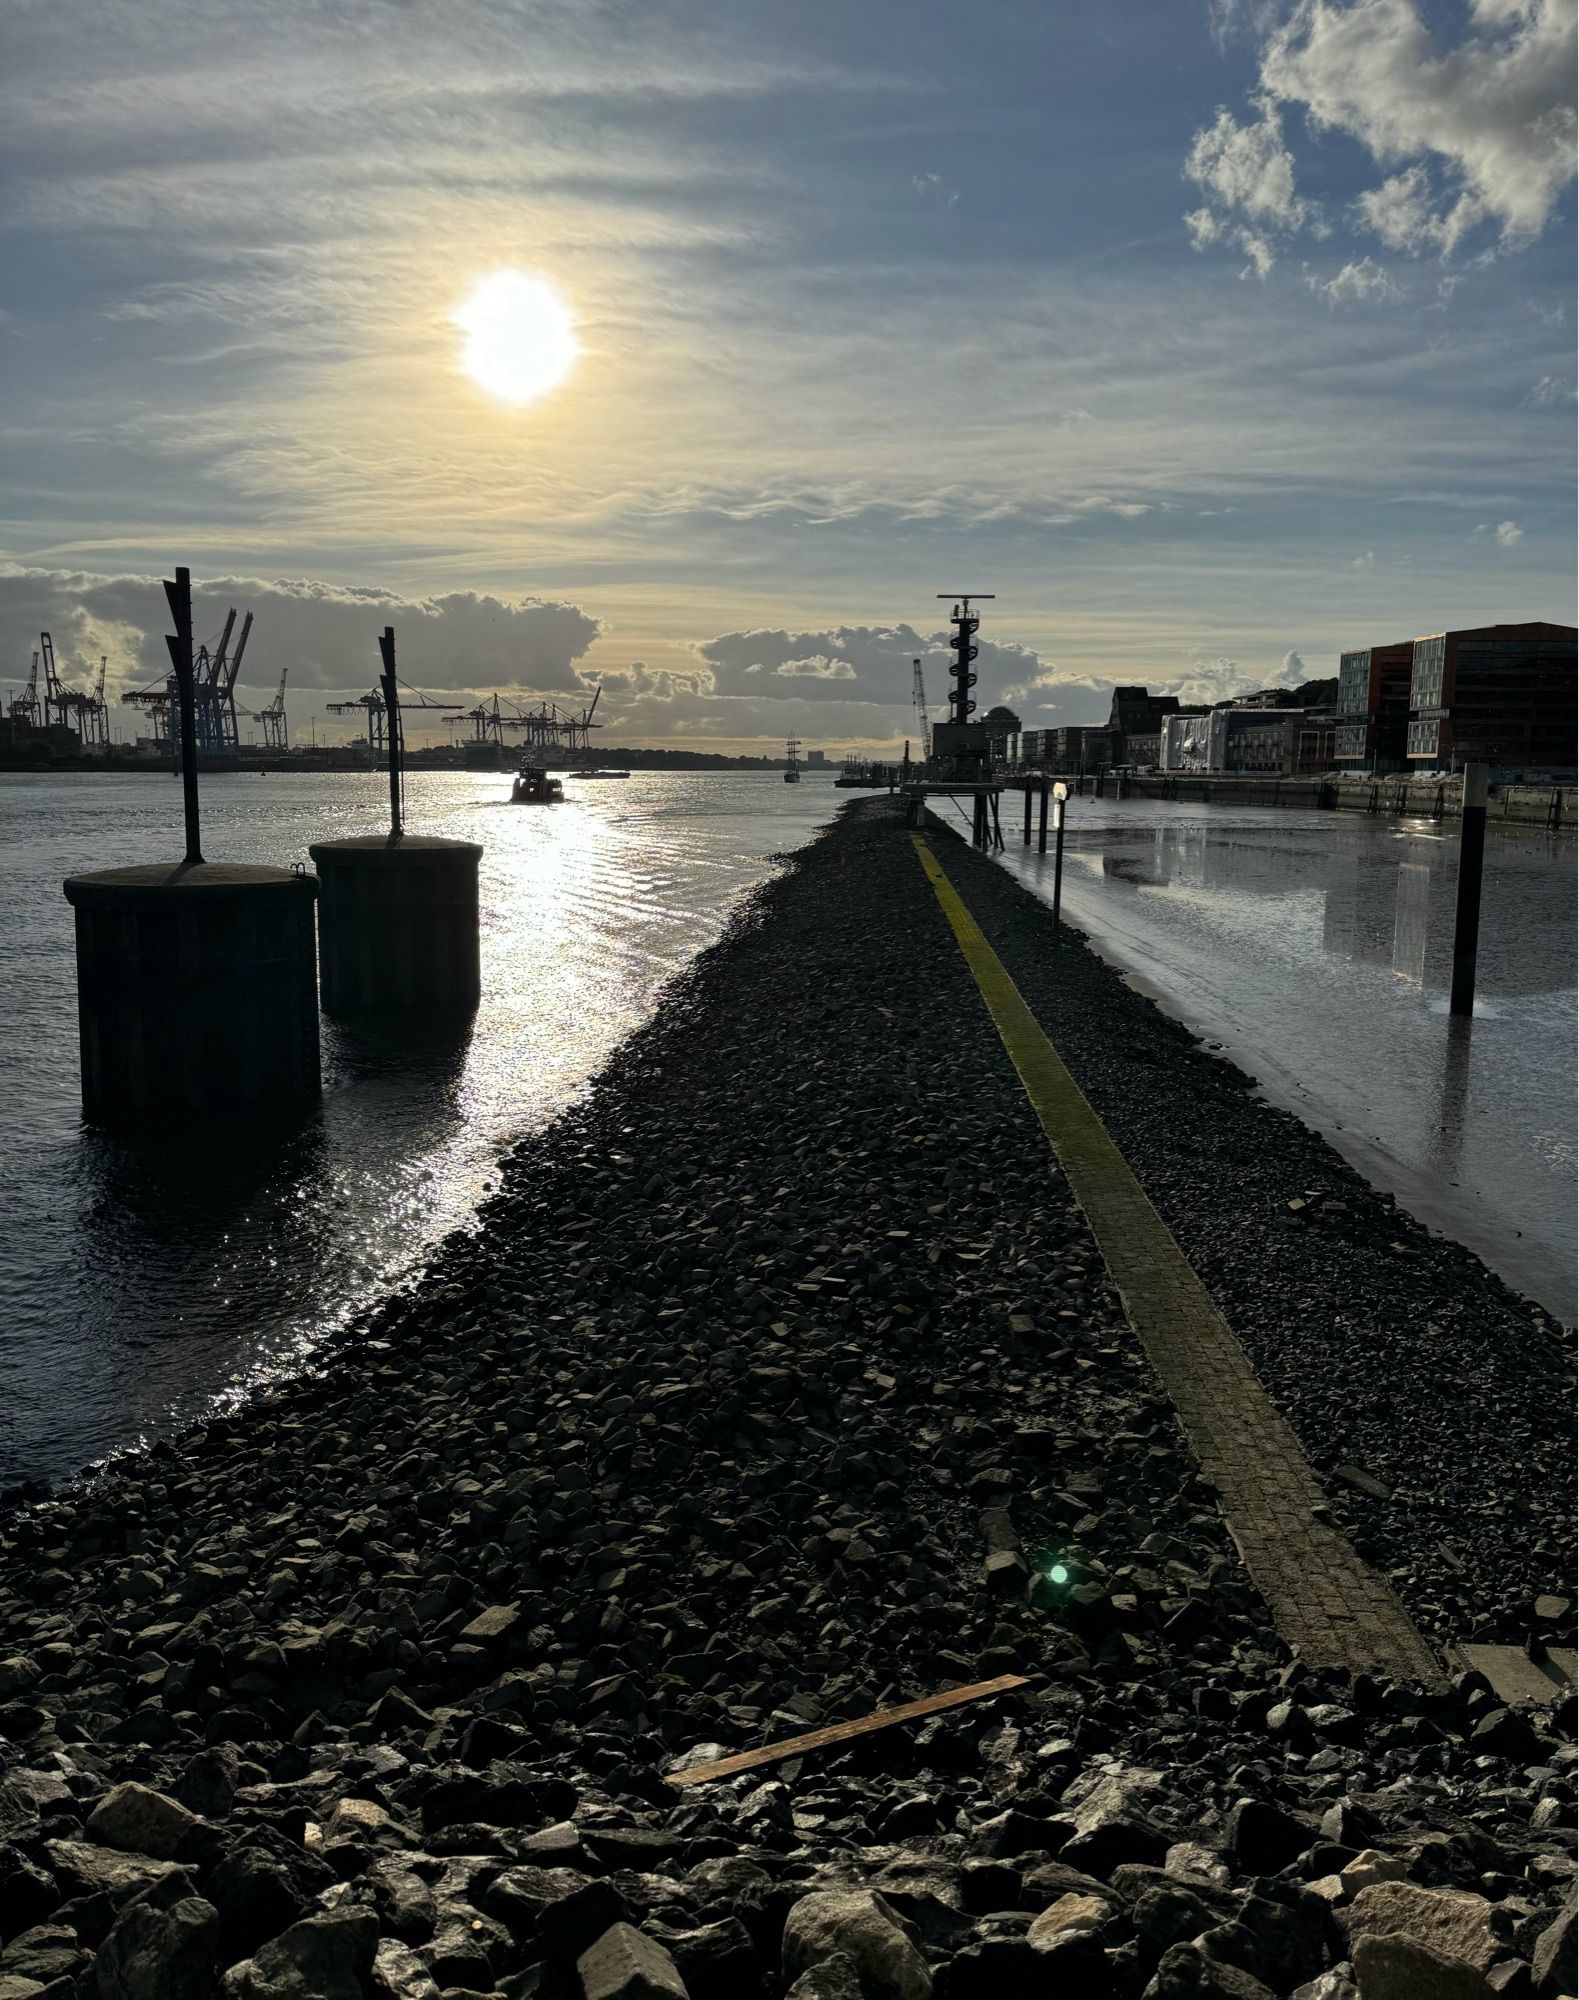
911 836 1441 1682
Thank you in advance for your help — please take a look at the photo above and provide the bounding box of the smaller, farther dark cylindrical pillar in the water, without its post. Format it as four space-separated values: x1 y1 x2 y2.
308 834 482 1014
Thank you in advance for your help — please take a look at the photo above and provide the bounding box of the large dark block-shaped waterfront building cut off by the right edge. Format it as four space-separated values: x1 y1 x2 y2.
1407 620 1579 780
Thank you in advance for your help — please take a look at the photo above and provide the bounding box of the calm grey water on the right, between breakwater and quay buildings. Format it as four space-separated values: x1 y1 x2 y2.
1003 798 1575 1322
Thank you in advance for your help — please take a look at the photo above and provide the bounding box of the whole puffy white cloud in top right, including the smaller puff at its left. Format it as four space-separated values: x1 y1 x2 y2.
1185 0 1579 276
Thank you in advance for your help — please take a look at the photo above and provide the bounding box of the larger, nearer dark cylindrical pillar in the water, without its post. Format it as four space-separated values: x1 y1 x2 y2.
66 862 320 1126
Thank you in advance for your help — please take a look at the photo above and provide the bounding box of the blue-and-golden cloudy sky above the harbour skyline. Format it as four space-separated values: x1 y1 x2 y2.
0 0 1579 752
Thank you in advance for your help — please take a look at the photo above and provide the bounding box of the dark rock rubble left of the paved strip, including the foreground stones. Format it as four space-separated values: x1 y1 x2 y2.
0 802 1575 2000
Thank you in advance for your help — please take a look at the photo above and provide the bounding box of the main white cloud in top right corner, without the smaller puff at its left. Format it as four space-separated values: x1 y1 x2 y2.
1261 0 1577 252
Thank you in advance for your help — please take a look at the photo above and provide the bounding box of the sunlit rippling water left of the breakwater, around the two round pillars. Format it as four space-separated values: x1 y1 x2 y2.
0 772 845 1486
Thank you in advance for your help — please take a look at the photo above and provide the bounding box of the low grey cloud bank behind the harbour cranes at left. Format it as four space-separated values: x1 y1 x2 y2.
0 564 600 694
